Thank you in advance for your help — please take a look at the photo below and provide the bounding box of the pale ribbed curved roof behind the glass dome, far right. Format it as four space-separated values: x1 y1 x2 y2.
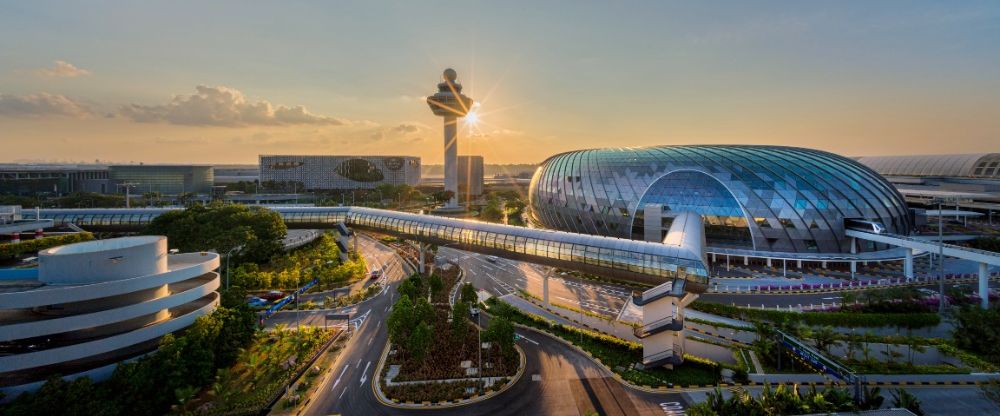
857 153 1000 178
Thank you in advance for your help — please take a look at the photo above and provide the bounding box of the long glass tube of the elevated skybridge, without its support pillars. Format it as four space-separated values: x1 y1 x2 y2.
28 207 708 292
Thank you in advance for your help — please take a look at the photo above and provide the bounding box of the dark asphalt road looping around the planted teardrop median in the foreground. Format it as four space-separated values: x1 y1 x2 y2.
305 240 686 415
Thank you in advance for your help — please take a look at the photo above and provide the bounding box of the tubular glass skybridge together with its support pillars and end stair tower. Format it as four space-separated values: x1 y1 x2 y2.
27 207 709 366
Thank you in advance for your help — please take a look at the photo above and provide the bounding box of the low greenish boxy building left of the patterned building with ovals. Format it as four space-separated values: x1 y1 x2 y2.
109 165 215 195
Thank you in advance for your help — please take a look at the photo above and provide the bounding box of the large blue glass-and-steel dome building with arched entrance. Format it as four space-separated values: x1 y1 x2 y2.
529 145 912 253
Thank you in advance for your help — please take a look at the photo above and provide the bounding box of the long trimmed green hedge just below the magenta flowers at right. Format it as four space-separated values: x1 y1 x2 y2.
691 302 941 329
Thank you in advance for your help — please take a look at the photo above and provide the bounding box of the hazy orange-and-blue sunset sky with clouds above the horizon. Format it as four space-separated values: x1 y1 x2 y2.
0 0 1000 164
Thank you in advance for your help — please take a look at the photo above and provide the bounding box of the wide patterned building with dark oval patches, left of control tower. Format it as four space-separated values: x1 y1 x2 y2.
260 155 420 190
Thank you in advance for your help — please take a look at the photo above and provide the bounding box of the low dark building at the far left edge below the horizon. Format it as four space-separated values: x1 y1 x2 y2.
0 165 109 196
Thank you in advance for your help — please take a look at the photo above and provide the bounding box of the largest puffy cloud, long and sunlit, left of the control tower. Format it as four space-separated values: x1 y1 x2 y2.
119 85 349 127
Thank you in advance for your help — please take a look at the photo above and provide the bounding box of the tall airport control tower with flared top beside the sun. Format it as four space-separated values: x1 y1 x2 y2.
427 68 472 212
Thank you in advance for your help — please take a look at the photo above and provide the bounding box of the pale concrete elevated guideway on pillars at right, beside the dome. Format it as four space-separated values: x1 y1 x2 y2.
846 228 1000 308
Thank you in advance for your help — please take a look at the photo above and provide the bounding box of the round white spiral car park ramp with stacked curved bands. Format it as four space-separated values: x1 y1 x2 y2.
0 236 219 397
